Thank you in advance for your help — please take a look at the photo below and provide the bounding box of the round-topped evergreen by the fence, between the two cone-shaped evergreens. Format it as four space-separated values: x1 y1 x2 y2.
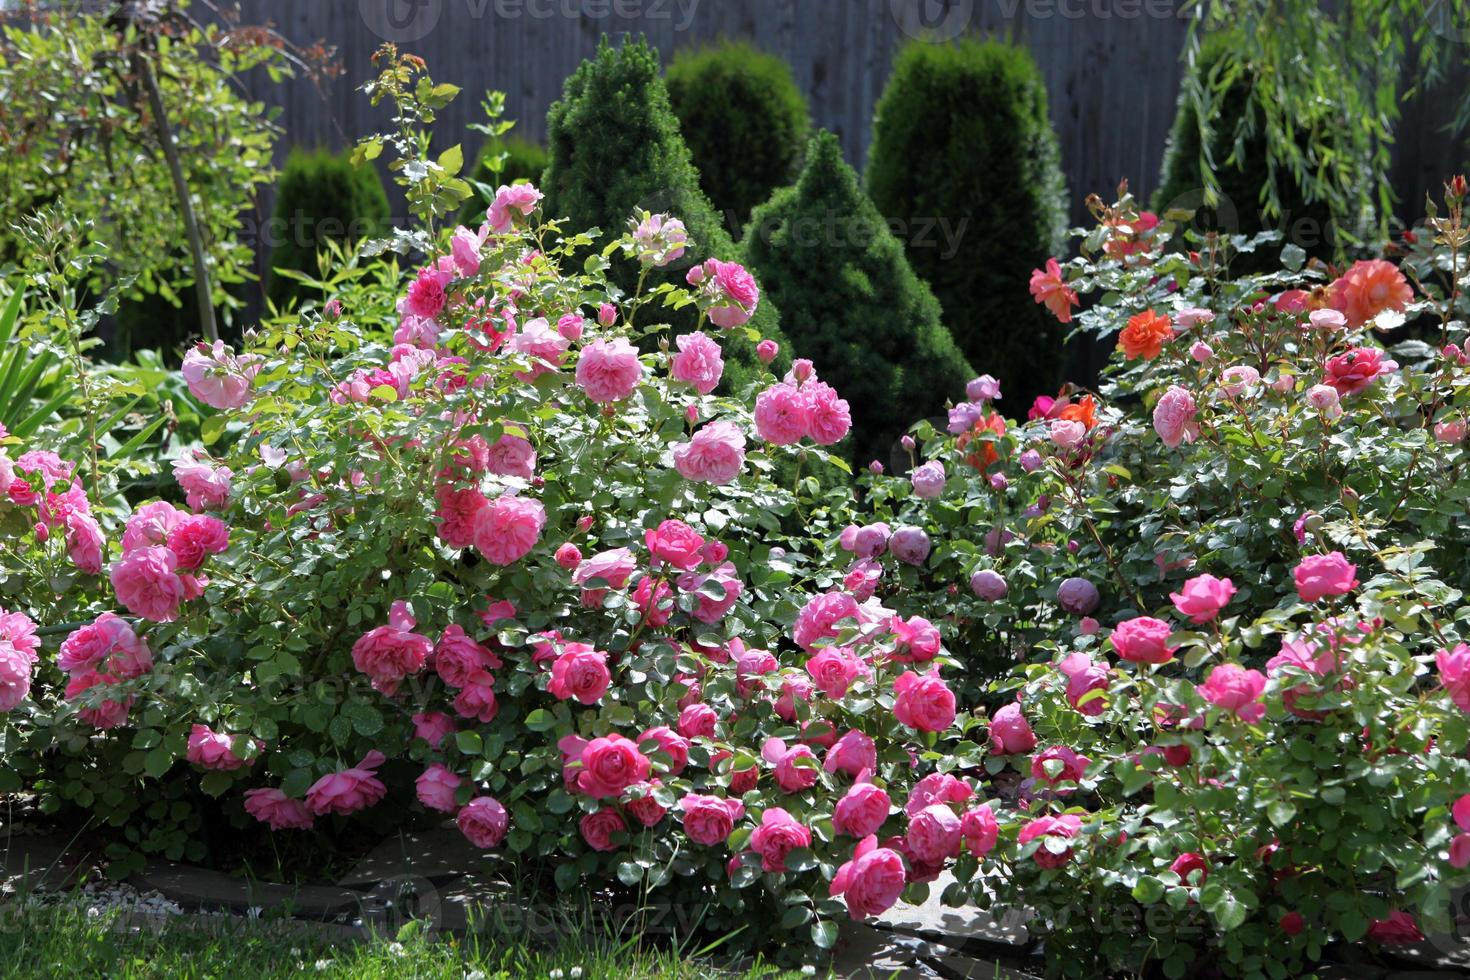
664 41 811 220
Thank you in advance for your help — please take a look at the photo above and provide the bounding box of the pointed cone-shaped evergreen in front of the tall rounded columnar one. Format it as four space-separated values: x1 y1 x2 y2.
744 131 973 464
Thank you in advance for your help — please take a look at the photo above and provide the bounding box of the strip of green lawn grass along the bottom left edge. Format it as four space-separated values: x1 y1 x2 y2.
0 901 795 980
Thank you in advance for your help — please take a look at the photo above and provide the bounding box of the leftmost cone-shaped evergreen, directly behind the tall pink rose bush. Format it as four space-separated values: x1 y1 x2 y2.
541 38 789 389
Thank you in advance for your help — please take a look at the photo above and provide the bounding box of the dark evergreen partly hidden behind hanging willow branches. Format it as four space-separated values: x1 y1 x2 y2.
1152 31 1372 272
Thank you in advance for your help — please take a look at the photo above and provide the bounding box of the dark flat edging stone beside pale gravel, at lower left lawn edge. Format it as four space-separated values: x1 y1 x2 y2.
128 861 363 921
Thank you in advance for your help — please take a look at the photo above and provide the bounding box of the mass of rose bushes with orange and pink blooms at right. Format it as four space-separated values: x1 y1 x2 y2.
829 182 1470 977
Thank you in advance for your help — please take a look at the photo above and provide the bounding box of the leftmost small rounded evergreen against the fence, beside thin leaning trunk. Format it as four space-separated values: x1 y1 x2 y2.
268 150 388 307
